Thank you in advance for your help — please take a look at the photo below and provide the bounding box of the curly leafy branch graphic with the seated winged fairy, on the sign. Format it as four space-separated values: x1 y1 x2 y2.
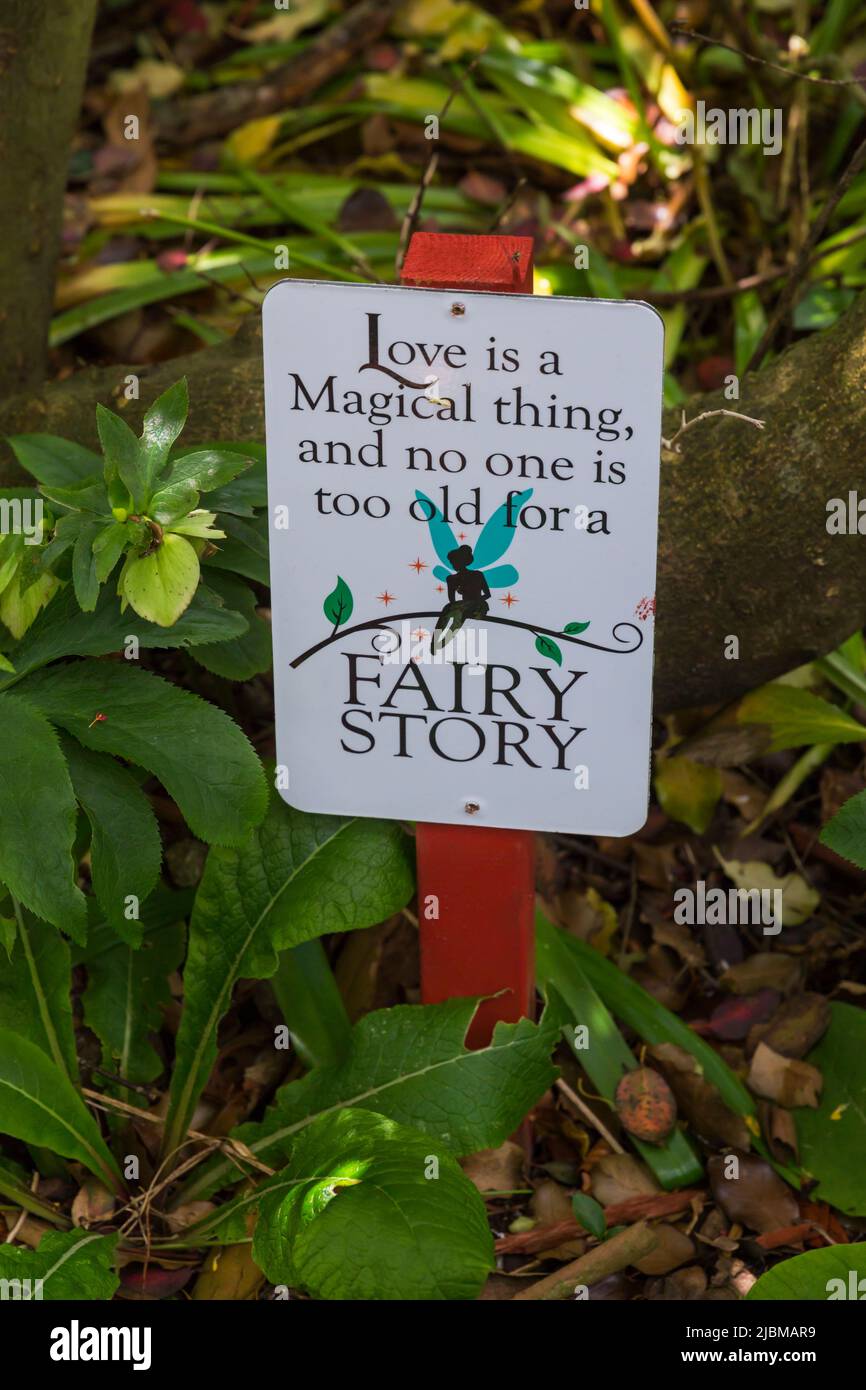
291 488 644 669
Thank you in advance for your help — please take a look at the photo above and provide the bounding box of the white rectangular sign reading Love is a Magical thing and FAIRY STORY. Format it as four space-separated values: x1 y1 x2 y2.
264 281 663 835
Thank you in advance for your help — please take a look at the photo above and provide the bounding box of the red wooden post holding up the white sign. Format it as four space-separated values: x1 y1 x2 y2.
402 232 535 1048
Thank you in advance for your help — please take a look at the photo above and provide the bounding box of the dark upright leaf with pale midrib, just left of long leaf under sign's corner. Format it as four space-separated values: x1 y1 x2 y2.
79 911 186 1086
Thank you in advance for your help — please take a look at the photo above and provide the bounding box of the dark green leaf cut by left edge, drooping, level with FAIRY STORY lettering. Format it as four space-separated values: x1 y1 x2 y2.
0 694 86 940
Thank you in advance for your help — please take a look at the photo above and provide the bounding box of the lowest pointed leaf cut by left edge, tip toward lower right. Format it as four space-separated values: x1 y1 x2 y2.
0 1029 122 1191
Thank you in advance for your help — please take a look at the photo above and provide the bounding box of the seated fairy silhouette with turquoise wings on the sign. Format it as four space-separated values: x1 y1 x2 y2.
416 488 532 646
